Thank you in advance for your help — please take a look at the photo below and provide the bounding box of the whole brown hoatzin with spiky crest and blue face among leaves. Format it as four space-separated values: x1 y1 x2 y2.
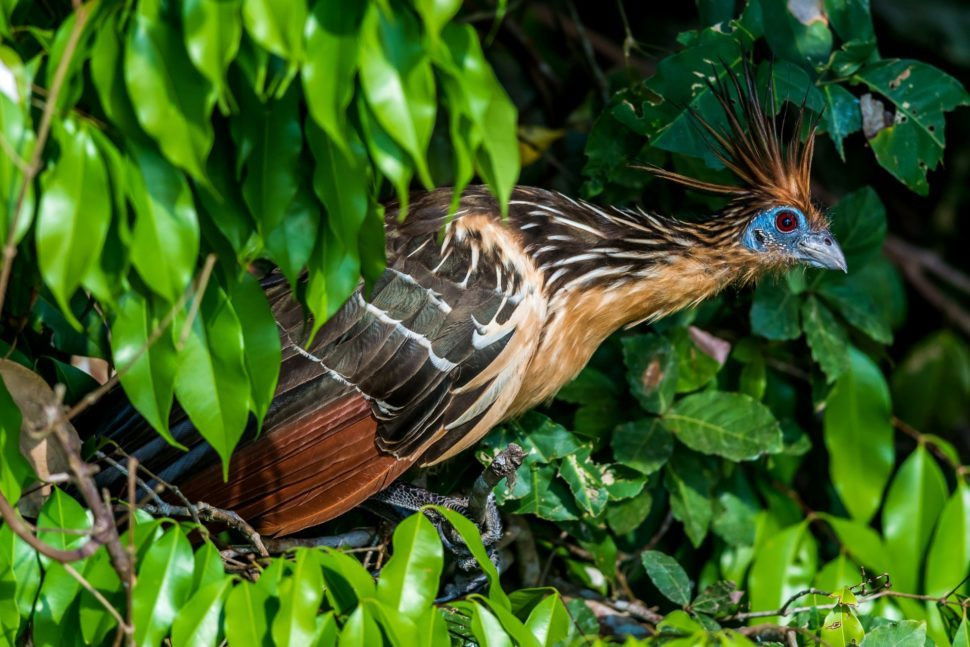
87 70 845 535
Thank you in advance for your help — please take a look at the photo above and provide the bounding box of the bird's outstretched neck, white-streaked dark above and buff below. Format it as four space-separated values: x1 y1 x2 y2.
512 195 759 413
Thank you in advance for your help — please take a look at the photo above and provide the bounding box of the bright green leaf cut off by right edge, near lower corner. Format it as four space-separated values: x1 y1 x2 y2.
923 479 970 596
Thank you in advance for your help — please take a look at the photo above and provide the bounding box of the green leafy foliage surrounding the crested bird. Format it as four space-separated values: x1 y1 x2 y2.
0 0 970 645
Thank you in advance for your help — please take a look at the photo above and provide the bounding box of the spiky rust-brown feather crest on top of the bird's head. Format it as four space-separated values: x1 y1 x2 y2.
645 61 824 228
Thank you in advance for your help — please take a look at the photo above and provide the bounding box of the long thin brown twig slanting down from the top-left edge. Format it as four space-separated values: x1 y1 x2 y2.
0 0 92 312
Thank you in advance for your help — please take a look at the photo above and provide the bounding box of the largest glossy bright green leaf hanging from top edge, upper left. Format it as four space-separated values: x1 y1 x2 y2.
124 0 216 181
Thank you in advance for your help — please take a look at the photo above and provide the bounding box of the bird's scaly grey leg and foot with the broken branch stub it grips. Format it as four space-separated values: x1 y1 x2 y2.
372 444 525 571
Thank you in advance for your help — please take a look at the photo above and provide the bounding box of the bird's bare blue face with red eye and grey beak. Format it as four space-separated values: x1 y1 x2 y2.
741 205 846 272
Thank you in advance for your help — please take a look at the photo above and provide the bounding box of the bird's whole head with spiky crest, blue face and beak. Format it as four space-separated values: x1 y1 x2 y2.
647 61 847 271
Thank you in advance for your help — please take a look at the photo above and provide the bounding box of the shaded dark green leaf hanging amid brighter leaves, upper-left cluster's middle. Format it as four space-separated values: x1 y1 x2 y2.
238 87 303 234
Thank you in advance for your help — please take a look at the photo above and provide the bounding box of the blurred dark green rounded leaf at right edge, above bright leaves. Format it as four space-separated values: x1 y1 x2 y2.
892 330 970 429
